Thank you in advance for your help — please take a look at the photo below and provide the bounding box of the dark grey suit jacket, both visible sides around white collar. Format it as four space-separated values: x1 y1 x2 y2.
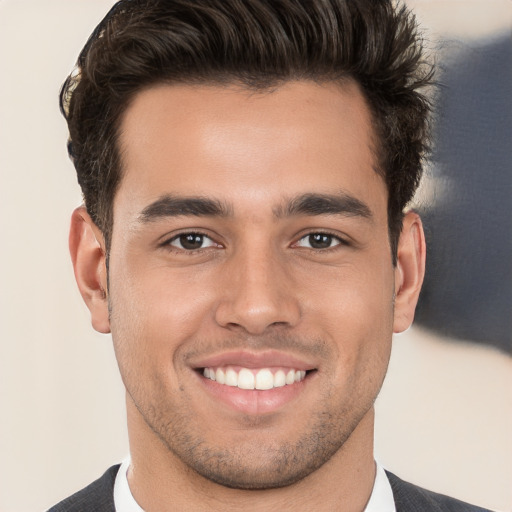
48 465 490 512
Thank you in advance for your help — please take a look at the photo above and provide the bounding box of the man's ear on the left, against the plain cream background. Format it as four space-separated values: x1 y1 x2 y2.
69 206 110 334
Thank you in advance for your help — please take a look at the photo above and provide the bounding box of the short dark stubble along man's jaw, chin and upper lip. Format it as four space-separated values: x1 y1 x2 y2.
114 296 385 490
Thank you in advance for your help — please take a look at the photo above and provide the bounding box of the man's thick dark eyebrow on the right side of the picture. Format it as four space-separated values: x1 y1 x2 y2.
274 192 373 220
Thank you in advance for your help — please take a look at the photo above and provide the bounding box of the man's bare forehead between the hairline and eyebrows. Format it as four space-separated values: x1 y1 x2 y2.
114 81 387 218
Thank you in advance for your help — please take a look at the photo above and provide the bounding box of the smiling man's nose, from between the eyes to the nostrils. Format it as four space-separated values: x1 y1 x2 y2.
215 247 301 335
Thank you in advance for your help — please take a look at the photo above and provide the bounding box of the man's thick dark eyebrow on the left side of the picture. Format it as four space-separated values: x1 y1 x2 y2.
139 195 232 222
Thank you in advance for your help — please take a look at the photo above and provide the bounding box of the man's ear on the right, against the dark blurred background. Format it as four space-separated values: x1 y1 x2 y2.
393 212 426 333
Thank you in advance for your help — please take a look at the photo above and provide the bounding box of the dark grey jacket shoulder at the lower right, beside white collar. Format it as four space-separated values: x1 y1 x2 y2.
386 471 491 512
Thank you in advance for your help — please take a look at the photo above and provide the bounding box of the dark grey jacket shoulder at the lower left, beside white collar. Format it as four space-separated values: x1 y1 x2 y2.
48 464 119 512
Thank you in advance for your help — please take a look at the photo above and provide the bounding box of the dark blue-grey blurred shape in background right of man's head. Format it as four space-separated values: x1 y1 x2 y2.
416 37 512 354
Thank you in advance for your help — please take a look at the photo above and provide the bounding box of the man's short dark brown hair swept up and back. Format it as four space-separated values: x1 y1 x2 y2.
60 0 432 257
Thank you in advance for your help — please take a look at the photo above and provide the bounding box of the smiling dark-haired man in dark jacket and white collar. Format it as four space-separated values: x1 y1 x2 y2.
51 0 492 512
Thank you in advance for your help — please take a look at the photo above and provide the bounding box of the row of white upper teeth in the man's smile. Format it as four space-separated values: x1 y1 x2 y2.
203 367 306 390
